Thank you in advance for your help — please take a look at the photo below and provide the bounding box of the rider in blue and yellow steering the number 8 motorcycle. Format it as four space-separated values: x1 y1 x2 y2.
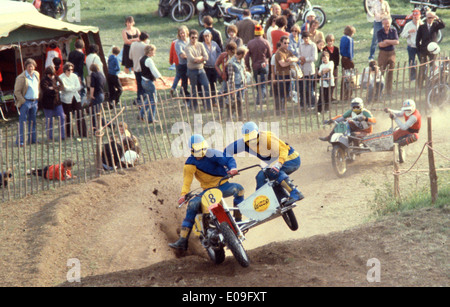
169 134 244 250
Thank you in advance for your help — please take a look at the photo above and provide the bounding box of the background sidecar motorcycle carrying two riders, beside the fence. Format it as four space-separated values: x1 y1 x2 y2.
326 120 405 177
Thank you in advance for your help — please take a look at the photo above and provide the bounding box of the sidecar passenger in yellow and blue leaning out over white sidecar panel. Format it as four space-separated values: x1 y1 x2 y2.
224 122 304 203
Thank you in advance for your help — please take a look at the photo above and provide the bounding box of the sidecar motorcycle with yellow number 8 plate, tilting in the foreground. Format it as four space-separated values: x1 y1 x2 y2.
179 165 298 267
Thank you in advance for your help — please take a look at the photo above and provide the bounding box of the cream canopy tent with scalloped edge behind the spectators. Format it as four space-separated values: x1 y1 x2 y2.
0 0 107 98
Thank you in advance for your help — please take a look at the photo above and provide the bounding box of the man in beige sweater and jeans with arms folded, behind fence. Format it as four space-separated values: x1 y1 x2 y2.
184 29 210 108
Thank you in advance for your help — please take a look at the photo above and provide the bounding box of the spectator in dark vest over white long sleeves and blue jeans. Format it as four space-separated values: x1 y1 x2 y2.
140 45 166 123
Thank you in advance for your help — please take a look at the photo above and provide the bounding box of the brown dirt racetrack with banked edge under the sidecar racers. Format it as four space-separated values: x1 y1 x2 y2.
0 111 450 286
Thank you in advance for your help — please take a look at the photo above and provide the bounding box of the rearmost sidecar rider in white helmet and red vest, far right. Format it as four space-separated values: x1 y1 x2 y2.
384 99 422 146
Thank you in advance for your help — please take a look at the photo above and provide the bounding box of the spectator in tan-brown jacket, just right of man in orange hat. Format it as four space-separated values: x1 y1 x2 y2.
275 35 298 114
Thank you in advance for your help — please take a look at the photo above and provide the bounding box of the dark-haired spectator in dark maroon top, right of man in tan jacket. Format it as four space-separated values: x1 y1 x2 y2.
40 66 66 141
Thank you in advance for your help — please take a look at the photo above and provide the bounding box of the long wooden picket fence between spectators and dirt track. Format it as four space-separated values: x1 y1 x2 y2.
0 57 449 202
